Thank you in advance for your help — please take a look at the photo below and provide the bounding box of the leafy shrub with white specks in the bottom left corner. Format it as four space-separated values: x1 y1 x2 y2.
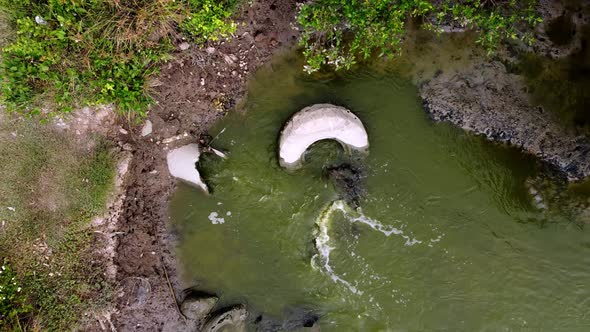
0 262 30 329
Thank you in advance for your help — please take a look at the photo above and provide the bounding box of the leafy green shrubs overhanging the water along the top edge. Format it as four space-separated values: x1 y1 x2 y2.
298 0 540 72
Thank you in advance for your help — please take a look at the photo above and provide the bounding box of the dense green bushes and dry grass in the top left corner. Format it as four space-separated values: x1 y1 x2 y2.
0 0 236 116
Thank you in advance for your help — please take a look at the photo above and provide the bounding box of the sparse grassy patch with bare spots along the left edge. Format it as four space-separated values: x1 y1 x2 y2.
0 120 115 331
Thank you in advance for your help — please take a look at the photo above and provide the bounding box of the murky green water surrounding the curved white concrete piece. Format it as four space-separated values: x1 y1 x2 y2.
171 54 590 331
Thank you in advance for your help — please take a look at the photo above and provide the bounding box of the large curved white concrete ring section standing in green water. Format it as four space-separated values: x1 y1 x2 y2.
279 104 369 168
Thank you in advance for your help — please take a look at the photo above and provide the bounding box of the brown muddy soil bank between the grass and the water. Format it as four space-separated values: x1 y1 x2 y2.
107 0 298 331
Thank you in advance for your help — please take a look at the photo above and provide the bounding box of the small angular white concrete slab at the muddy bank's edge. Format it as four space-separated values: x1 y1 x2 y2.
166 144 209 192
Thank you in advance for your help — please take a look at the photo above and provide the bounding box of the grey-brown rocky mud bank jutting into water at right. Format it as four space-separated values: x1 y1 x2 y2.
420 62 590 181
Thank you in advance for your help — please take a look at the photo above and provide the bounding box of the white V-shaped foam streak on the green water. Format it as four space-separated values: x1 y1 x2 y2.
311 200 422 295
